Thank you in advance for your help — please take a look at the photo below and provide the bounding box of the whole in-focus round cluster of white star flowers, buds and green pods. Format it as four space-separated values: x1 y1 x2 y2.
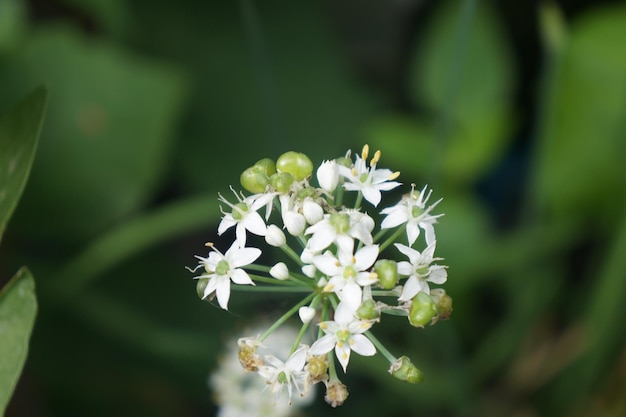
192 145 452 407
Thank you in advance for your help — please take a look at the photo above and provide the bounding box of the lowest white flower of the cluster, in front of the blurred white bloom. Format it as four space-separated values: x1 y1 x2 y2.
259 346 309 403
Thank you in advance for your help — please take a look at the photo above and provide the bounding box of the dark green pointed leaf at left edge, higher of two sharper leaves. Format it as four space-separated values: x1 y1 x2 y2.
0 87 48 239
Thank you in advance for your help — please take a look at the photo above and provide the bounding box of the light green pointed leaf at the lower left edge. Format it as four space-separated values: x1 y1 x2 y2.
0 268 37 416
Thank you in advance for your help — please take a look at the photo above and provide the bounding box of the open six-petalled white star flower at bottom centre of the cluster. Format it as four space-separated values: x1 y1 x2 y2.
309 303 376 372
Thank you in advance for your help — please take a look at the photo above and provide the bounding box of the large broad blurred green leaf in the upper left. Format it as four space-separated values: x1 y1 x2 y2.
0 27 184 240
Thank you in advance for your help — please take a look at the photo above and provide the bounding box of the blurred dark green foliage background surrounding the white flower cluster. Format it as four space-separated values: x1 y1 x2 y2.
0 0 626 417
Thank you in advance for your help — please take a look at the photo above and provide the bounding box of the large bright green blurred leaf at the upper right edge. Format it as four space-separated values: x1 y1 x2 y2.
534 5 626 225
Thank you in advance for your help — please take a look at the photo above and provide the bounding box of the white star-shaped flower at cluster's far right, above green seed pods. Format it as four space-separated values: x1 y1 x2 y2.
394 241 448 301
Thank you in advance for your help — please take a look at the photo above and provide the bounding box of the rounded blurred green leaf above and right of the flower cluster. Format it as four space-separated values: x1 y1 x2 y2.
398 3 516 183
